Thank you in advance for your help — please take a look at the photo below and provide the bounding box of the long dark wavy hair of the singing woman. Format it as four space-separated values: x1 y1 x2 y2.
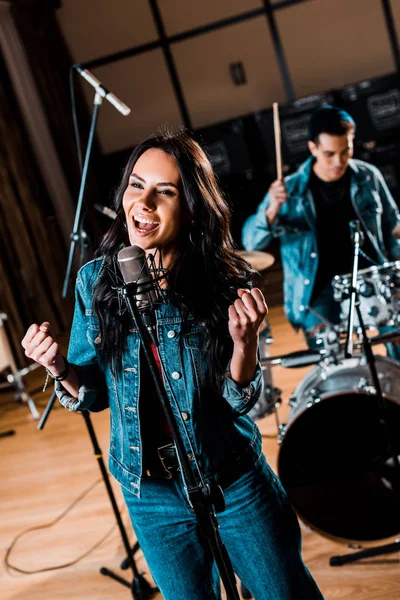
93 132 254 387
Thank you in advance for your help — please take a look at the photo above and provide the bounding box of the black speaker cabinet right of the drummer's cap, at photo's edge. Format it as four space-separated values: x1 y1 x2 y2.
339 73 400 144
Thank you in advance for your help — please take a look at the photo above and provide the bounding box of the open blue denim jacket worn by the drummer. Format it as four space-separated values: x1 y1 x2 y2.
242 157 400 329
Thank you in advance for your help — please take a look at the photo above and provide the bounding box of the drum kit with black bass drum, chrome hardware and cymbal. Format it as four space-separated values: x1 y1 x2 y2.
242 252 400 552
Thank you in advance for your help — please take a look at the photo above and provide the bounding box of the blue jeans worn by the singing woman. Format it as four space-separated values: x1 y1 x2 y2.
123 455 323 600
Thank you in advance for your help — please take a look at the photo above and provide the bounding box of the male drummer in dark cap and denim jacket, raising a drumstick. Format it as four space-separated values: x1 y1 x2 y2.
242 106 400 356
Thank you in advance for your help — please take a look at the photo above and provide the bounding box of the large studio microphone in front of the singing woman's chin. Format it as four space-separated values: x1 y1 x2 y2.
118 246 158 343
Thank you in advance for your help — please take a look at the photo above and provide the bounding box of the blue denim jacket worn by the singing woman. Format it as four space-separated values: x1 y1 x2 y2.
56 258 262 497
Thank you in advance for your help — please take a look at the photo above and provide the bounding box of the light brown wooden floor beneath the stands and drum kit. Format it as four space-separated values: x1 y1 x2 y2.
0 308 400 600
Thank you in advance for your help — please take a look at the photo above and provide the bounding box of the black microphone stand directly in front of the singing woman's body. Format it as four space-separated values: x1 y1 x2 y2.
120 283 239 600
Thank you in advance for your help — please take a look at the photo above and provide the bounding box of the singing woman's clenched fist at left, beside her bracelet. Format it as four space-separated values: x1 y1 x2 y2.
21 321 65 377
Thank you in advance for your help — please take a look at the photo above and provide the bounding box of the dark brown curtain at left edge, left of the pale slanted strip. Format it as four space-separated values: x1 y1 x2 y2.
0 48 72 367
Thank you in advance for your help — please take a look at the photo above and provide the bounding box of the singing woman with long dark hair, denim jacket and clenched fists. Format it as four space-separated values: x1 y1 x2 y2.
22 133 322 600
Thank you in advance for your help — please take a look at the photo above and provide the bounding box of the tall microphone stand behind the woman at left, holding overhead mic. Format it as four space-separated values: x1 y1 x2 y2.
37 80 158 600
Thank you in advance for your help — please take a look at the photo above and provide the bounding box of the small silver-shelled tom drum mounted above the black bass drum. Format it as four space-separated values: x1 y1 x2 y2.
332 261 400 330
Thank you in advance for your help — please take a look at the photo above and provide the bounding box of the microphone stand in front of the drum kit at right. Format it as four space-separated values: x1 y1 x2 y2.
329 221 400 567
